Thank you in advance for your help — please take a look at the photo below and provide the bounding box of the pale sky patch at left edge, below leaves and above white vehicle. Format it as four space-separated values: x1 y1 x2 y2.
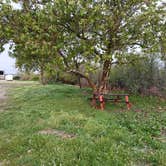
0 44 18 74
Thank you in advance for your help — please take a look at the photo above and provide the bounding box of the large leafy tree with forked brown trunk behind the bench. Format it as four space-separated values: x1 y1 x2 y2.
53 0 162 93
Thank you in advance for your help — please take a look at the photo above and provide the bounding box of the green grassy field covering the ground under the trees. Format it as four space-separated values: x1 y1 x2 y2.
0 85 166 166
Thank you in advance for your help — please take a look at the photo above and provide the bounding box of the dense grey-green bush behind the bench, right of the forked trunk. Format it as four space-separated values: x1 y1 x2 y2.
110 56 166 95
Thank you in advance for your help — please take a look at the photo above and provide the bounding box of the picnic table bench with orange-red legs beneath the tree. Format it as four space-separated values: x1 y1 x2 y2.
91 93 131 110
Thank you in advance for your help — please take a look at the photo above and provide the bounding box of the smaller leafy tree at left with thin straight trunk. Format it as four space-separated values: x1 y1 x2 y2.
7 1 60 84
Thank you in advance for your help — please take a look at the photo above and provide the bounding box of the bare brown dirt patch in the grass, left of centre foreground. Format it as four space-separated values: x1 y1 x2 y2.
39 129 76 139
